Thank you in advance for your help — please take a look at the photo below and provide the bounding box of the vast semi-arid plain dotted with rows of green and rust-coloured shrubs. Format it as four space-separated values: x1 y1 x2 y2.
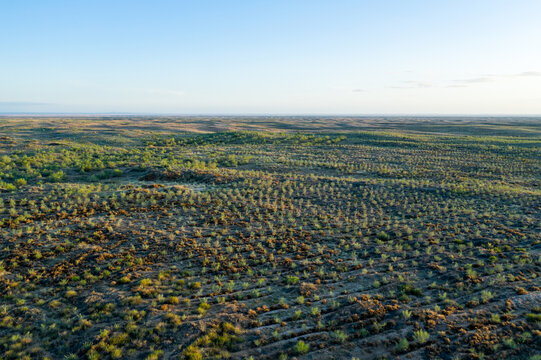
0 117 541 360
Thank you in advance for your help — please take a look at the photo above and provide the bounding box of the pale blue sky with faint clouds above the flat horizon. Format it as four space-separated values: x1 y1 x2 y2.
0 0 541 115
